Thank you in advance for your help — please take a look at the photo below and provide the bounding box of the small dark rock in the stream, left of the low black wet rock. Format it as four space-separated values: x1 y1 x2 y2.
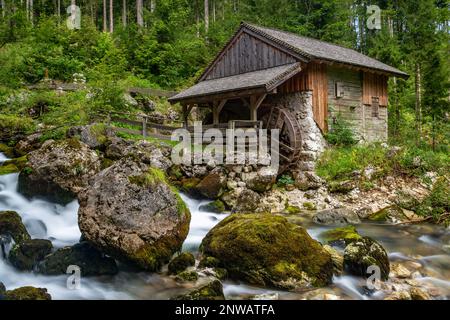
8 239 53 271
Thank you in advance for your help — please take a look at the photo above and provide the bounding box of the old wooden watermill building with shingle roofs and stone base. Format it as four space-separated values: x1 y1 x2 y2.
169 23 408 171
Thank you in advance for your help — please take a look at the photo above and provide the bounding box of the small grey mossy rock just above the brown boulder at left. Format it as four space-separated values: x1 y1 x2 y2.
66 123 115 150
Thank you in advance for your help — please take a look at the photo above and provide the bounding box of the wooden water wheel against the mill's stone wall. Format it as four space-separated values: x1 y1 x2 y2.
262 107 302 174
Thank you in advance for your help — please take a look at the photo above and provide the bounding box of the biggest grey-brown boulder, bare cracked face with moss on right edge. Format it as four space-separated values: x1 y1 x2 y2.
78 157 190 271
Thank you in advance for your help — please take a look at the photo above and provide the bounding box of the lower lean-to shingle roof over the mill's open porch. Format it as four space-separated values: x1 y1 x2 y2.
169 62 301 102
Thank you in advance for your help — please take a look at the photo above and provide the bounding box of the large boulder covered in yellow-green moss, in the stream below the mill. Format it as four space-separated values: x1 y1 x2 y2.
200 214 333 289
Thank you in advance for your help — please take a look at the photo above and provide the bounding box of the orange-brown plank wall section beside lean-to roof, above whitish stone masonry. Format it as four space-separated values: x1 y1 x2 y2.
278 63 328 132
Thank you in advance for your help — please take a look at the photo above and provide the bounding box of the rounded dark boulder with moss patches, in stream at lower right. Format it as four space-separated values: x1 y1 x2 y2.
344 237 390 280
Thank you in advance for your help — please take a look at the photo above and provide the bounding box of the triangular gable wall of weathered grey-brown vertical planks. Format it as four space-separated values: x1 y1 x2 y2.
206 32 296 80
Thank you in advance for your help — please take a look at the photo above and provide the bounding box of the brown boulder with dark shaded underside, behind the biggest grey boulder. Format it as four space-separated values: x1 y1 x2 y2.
19 138 100 204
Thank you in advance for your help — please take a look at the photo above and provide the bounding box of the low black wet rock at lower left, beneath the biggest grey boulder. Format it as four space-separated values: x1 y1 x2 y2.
37 242 118 277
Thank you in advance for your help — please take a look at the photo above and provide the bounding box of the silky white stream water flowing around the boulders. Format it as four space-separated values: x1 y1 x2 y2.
0 153 450 299
